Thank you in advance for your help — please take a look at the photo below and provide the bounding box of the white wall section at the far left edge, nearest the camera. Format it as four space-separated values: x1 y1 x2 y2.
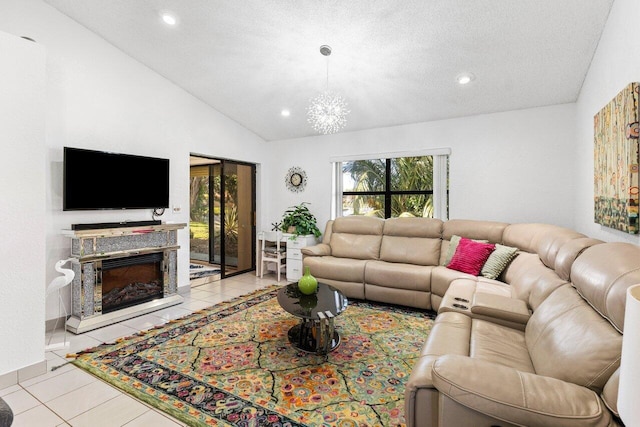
0 32 45 376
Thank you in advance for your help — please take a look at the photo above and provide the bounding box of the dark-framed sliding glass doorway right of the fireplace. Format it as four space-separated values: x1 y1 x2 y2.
189 154 256 286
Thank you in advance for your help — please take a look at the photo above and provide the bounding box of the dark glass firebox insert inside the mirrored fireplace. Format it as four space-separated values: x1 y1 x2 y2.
102 253 164 313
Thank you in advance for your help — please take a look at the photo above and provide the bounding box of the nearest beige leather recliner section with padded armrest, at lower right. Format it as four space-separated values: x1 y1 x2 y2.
405 243 640 427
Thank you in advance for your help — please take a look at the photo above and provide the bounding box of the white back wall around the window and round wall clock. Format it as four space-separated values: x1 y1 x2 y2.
263 104 575 229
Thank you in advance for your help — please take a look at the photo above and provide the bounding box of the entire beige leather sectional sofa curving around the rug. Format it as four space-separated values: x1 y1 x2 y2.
303 217 640 427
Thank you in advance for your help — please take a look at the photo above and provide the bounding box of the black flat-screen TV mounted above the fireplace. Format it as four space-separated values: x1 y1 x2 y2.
62 147 169 211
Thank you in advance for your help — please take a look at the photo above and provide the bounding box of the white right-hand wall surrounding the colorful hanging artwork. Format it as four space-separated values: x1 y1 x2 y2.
573 0 640 244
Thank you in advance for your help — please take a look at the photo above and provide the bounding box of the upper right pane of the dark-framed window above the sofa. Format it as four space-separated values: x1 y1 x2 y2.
391 156 433 191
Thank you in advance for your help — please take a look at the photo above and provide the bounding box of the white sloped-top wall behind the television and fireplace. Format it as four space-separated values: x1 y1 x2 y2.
0 0 267 327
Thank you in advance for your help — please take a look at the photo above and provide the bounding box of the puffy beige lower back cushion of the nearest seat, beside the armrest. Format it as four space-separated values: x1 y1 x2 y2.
525 286 622 392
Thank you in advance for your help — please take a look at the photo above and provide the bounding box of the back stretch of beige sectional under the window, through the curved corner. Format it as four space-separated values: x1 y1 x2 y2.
302 216 601 311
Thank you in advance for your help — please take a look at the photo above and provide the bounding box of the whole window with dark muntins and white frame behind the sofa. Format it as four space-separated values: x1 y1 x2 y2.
334 150 449 219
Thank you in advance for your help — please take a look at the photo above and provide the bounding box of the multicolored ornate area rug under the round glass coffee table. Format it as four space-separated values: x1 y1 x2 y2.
74 286 433 427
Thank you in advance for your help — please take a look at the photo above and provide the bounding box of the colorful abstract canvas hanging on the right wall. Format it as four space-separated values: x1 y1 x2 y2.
593 83 640 234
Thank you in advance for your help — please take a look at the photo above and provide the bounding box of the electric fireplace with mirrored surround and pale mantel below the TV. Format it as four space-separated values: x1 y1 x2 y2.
65 224 186 334
